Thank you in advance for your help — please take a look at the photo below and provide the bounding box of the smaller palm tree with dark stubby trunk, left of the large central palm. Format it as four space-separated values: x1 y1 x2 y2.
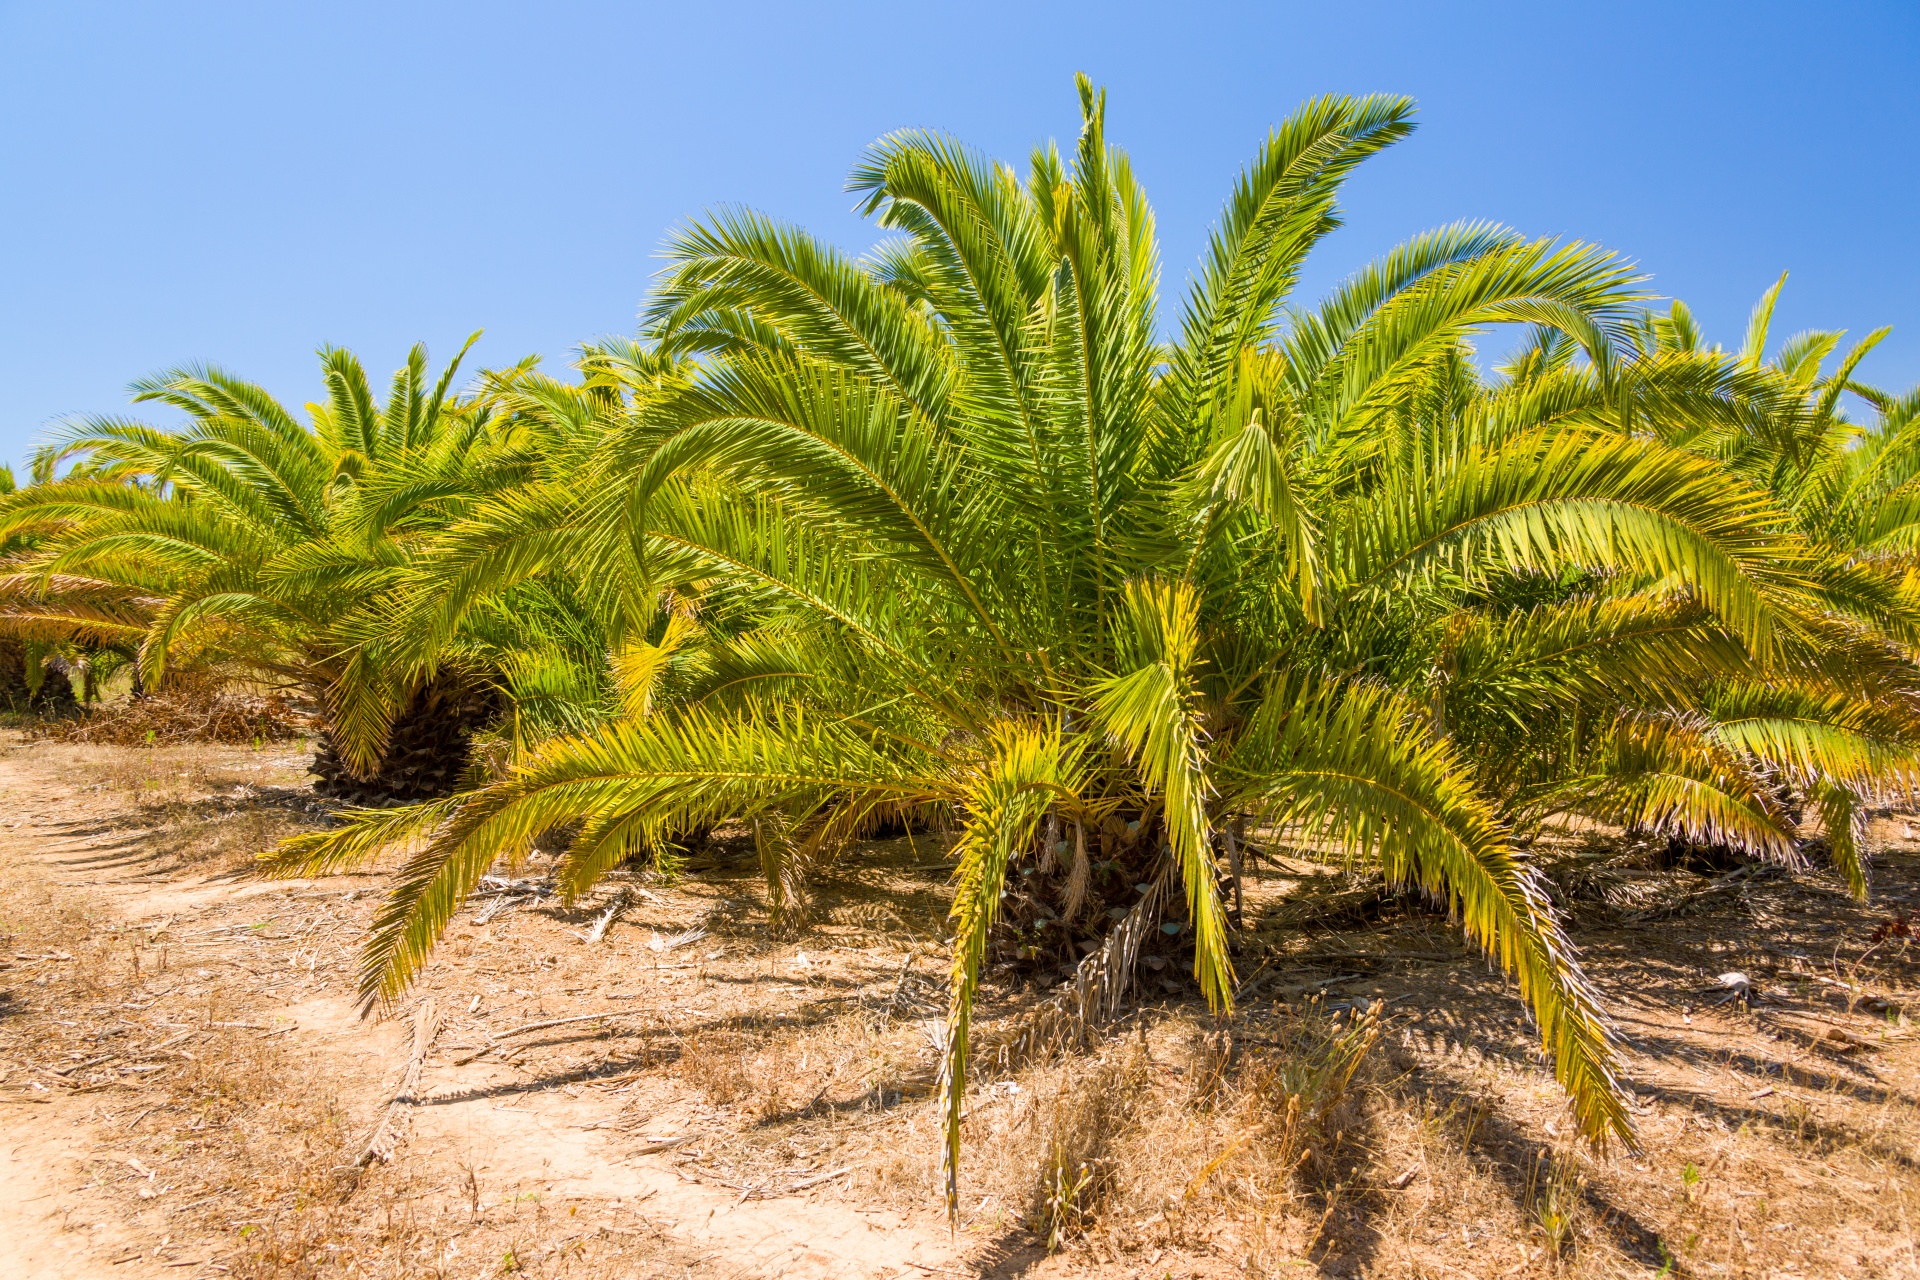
0 340 526 802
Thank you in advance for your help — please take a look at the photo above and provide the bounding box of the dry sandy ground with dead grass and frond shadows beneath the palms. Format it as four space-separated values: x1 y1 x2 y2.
0 733 1920 1280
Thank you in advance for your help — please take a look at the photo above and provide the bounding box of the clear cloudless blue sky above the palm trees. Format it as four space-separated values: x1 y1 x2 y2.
0 0 1920 461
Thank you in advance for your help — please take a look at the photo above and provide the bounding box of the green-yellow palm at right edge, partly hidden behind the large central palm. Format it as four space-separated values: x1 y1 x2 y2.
1474 276 1920 898
